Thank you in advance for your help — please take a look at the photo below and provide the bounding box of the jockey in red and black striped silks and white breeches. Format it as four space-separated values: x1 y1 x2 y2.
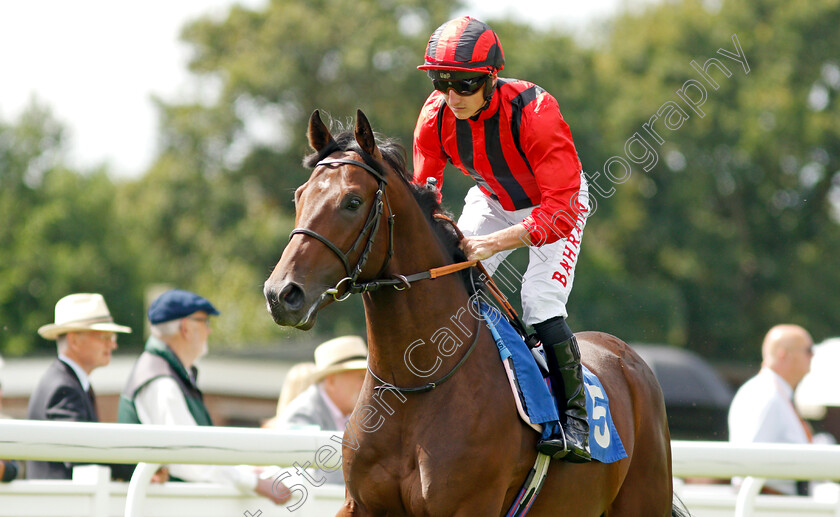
413 16 590 463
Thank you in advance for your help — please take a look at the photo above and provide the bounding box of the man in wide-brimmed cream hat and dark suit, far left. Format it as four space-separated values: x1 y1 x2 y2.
26 293 134 479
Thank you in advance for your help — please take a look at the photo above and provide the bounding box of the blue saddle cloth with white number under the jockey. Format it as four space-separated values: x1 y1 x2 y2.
481 302 627 463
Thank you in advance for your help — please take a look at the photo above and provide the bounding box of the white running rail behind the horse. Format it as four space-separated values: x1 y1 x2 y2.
0 420 840 517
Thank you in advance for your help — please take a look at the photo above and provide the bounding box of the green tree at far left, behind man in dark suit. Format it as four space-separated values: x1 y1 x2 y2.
0 103 143 355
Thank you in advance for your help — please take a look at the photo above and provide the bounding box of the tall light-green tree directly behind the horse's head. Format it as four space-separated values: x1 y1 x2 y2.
125 0 462 344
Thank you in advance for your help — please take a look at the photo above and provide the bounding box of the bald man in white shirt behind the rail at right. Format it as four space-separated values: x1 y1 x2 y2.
729 325 814 495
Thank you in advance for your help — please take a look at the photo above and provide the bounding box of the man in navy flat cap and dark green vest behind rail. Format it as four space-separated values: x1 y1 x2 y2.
119 289 291 504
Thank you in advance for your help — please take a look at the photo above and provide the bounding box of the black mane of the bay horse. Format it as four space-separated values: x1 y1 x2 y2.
303 130 475 294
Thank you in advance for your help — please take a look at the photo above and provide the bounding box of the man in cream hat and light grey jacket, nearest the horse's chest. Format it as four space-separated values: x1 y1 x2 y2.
277 336 367 484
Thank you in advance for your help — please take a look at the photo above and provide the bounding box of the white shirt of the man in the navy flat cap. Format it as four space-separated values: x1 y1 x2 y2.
134 377 257 491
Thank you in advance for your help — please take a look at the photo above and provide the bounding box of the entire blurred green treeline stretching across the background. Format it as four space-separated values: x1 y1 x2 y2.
8 0 840 359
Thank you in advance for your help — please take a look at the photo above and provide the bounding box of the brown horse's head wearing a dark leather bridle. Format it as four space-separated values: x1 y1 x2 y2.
263 110 404 330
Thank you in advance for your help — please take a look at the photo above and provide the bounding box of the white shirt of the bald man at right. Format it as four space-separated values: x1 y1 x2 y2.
729 368 809 494
